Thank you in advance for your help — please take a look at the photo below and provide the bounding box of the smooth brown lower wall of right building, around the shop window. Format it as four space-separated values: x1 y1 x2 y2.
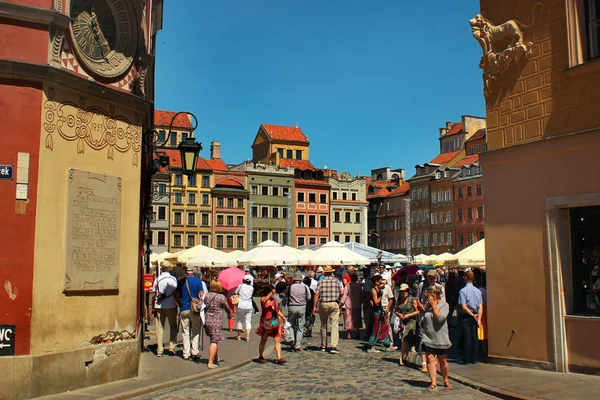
481 130 600 367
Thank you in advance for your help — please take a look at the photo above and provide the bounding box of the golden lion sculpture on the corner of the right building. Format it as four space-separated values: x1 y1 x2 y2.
469 2 543 97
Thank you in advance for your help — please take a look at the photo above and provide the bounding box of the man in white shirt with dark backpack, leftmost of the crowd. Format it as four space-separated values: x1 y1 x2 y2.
152 261 177 357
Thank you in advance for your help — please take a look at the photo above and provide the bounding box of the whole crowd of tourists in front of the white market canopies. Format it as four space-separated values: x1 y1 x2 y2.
153 262 487 391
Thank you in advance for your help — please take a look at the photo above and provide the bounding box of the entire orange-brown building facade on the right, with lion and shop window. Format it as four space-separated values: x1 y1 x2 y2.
470 0 600 373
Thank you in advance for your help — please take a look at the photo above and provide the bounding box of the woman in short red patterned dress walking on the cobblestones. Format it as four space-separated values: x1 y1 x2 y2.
256 288 287 364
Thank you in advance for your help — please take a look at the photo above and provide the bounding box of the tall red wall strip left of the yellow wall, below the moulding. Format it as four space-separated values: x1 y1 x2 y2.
0 78 42 355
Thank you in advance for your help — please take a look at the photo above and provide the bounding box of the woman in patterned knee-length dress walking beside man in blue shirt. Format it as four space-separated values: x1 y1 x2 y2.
202 280 232 369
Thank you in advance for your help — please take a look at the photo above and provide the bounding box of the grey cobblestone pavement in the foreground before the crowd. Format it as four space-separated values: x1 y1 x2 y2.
139 334 493 400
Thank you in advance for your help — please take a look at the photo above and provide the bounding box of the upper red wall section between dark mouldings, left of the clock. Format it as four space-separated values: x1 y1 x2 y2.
0 18 48 64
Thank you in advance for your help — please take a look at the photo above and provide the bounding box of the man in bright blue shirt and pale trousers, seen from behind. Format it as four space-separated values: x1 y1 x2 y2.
177 267 207 360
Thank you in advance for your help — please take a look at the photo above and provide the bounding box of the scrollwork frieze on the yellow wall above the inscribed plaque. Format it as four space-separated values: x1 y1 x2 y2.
42 87 142 166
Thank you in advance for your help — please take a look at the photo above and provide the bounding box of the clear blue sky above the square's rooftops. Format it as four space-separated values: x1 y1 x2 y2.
156 0 485 176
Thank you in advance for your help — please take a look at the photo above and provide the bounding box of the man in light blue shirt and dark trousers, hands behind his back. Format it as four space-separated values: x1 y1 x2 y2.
457 270 483 364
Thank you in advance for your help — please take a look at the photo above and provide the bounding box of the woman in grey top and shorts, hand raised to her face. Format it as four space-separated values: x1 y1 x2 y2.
419 286 452 392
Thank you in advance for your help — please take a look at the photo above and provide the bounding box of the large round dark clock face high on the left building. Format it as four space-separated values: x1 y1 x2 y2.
71 0 137 78
